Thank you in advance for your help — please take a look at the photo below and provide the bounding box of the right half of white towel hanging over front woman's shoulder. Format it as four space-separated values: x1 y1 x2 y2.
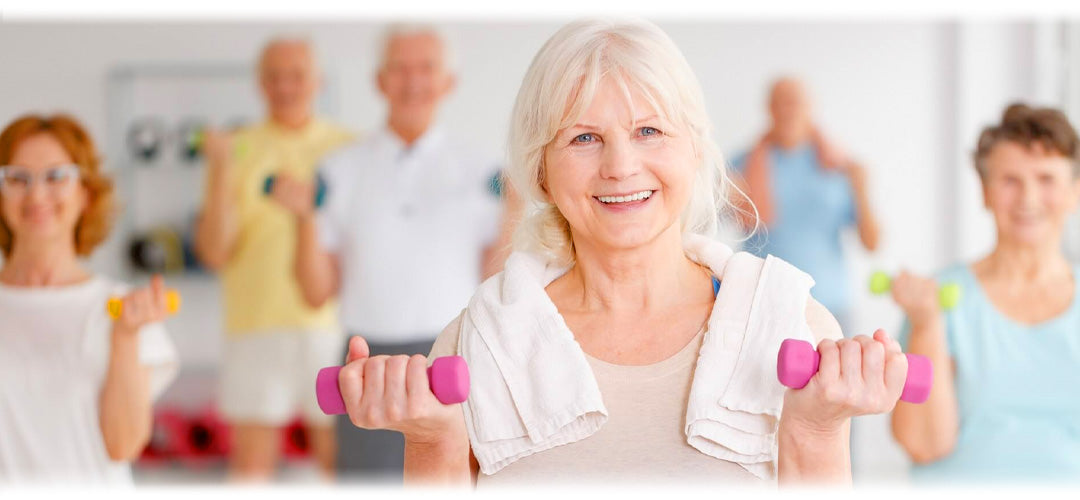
686 238 813 479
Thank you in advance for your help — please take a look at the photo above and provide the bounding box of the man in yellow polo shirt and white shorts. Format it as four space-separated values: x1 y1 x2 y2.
195 39 352 482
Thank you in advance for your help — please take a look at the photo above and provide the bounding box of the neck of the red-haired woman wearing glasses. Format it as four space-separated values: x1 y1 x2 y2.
0 240 90 286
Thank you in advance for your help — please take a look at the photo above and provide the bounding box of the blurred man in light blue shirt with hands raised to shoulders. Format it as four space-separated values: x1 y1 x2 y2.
732 77 879 336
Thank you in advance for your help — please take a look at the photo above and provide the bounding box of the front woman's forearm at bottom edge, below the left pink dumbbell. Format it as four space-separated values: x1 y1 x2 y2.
404 430 472 486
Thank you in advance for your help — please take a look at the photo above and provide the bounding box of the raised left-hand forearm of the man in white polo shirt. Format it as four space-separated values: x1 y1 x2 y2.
293 214 340 307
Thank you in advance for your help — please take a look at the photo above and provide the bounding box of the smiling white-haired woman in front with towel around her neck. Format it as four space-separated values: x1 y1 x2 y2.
338 22 907 485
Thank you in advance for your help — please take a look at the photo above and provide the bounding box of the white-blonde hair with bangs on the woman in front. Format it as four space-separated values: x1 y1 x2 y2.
507 21 745 265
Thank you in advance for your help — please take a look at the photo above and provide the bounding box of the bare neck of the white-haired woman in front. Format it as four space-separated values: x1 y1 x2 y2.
567 225 710 312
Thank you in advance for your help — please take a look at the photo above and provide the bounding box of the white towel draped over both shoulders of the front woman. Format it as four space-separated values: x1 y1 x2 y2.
458 234 813 479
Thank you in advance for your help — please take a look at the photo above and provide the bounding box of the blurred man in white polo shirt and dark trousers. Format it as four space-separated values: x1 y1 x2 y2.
274 25 505 481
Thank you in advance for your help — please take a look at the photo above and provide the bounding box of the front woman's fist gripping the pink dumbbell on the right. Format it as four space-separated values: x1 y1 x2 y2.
783 329 907 432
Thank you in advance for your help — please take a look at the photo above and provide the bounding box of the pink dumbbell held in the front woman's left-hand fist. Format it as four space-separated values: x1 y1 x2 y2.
315 356 469 415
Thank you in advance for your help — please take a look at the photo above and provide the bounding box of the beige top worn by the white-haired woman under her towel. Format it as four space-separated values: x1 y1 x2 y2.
432 317 768 488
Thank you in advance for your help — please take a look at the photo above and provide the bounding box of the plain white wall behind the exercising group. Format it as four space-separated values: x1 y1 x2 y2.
0 22 1054 485
